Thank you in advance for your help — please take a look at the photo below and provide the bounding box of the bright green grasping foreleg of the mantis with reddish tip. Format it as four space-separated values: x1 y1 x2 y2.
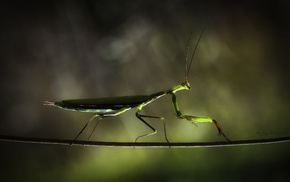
171 92 230 141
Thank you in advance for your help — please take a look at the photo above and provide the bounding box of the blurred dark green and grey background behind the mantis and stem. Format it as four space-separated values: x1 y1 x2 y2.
0 0 290 181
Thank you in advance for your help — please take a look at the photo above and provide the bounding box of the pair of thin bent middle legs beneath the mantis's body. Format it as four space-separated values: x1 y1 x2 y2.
135 104 169 143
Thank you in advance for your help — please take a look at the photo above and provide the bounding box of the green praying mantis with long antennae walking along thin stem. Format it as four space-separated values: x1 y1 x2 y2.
44 29 230 144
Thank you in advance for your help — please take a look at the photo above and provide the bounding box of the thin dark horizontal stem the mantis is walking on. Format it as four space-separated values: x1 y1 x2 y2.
0 135 290 148
